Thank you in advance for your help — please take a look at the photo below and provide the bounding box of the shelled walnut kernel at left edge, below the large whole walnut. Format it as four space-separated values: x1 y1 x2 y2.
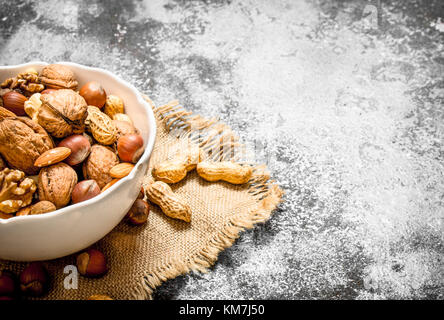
0 168 37 213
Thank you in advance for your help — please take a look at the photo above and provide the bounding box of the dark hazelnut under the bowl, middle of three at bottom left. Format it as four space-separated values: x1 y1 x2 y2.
20 262 49 297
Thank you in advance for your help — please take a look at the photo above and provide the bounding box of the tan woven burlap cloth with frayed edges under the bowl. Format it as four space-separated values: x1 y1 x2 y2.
0 98 282 299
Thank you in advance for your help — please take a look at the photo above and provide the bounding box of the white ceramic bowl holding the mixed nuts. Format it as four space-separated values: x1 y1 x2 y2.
0 62 156 261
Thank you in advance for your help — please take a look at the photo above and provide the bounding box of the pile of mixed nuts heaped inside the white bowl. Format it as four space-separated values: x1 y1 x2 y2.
0 64 149 219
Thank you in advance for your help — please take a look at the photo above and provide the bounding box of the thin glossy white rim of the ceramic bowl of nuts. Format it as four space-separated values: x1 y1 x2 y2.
0 61 157 226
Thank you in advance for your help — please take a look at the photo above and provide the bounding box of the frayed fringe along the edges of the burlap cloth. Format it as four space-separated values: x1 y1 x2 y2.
133 96 283 300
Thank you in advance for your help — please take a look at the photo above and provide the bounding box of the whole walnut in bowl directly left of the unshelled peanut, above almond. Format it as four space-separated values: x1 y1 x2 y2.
37 89 87 138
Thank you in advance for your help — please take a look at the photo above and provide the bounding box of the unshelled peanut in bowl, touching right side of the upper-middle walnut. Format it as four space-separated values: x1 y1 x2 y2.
86 106 117 145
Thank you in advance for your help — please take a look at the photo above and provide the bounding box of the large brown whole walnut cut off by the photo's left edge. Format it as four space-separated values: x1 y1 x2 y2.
0 112 54 175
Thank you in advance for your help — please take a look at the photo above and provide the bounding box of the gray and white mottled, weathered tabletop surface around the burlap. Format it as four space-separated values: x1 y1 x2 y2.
0 0 444 299
